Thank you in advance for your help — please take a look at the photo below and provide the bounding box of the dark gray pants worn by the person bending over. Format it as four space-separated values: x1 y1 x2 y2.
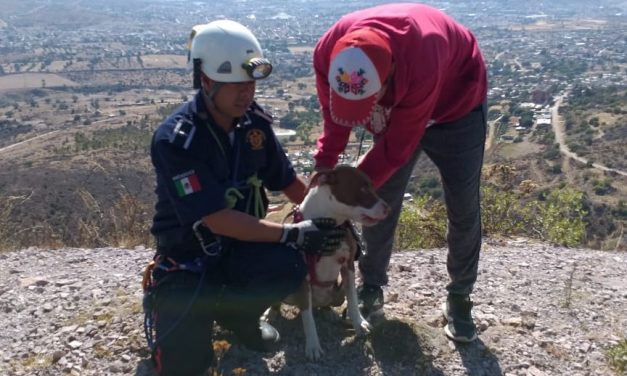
359 103 487 294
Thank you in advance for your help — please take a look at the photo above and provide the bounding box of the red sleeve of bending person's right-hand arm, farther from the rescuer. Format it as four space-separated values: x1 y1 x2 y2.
358 79 438 188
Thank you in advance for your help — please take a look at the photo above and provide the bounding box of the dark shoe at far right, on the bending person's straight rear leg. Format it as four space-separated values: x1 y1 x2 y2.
442 294 477 343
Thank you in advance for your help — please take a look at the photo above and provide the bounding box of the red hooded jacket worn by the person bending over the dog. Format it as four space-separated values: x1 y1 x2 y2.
313 4 487 187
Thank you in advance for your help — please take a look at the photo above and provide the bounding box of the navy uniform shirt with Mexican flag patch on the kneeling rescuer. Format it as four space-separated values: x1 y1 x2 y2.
151 92 296 250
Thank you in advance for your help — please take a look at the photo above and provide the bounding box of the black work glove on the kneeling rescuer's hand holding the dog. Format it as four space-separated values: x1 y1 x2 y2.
280 218 344 255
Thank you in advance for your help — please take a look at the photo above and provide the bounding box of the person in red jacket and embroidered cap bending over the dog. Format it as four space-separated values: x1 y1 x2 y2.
314 4 487 342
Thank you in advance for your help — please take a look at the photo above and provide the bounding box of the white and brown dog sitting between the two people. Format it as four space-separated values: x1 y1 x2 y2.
270 165 390 360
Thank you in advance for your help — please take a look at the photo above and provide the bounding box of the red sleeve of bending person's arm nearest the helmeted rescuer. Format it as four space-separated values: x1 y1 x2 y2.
314 41 351 170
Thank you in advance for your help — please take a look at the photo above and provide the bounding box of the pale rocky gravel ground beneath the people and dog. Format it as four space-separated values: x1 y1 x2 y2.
0 239 627 376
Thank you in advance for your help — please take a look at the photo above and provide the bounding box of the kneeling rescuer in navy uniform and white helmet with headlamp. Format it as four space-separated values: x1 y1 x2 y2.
144 20 343 375
